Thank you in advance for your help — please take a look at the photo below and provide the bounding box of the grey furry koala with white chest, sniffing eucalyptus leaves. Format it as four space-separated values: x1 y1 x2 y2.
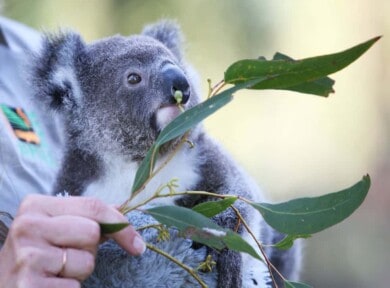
31 20 300 288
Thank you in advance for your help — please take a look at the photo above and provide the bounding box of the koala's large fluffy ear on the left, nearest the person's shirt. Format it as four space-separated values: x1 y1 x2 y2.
31 31 85 110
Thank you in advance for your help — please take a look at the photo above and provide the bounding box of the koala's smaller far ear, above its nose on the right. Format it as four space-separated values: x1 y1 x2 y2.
142 20 183 60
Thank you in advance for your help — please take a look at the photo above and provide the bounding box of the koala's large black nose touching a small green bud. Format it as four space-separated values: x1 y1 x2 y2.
163 65 190 104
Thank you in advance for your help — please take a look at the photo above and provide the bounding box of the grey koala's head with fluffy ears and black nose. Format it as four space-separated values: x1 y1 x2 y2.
33 21 199 161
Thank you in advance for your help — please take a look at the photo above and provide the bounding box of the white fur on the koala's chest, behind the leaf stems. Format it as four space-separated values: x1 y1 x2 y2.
83 146 200 206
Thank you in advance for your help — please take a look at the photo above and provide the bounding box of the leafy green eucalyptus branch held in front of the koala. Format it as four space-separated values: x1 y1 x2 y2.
107 37 380 287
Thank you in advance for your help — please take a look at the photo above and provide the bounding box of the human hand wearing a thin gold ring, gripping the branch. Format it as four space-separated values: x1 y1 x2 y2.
0 195 145 288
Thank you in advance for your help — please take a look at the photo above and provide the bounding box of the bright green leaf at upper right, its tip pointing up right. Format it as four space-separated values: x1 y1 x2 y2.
225 37 380 94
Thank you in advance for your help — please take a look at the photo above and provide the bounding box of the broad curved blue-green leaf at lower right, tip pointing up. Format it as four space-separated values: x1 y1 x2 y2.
251 175 371 235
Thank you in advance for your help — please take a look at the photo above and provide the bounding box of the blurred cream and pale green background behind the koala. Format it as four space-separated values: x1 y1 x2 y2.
0 0 390 288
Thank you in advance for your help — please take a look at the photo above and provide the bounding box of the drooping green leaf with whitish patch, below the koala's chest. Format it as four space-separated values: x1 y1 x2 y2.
145 206 261 260
